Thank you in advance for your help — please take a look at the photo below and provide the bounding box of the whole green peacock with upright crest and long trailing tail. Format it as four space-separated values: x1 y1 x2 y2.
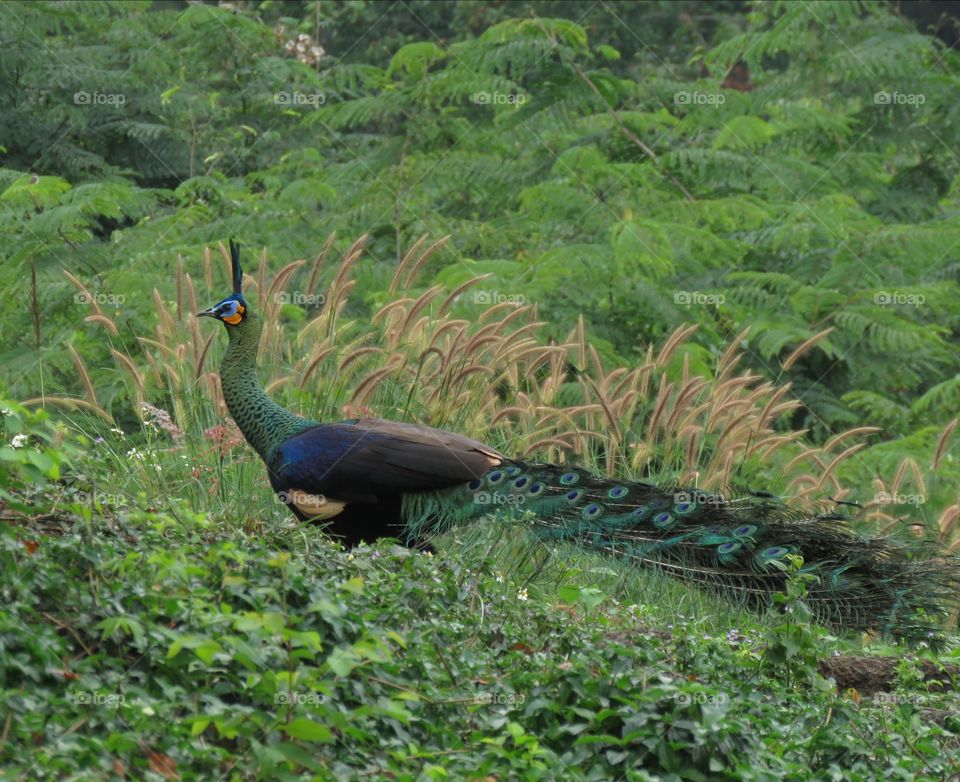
198 241 960 641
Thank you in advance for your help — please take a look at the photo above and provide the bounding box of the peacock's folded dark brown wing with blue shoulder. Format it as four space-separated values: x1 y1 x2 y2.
270 418 504 502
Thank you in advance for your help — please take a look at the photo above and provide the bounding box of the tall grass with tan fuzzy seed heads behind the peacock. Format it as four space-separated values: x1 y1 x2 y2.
28 236 960 549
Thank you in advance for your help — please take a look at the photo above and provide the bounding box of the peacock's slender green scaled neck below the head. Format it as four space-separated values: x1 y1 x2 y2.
220 309 317 463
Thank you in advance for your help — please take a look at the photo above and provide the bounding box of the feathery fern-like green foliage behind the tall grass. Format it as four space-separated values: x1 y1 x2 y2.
0 3 960 448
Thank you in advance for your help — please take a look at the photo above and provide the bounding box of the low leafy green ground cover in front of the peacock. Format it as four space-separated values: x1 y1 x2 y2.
0 486 958 780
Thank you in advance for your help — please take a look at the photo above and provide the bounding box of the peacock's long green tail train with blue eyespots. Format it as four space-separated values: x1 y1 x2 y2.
403 461 960 642
